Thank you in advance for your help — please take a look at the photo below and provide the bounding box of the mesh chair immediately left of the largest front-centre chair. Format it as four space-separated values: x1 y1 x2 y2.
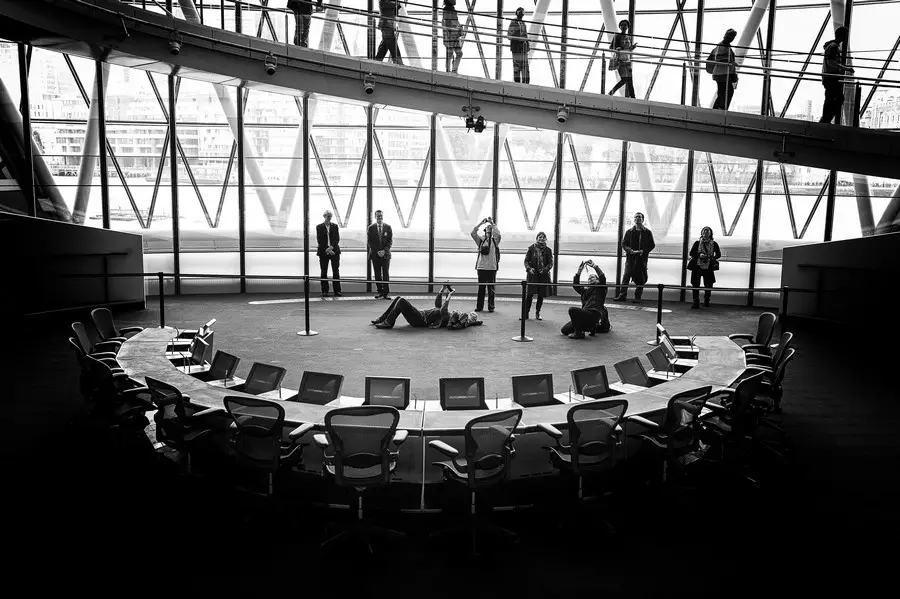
224 395 308 495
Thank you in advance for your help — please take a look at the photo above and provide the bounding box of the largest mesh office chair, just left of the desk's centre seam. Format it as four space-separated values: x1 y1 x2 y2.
313 406 408 554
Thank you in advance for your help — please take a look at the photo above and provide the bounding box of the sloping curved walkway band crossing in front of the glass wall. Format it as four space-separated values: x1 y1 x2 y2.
0 0 900 178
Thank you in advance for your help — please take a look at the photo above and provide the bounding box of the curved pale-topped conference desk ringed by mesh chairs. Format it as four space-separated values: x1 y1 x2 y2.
117 328 746 509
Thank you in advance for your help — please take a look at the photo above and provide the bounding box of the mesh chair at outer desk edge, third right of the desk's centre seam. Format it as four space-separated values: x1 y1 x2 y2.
626 386 712 481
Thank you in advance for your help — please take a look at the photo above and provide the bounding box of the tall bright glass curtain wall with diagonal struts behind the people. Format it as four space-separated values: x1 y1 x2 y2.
0 0 900 302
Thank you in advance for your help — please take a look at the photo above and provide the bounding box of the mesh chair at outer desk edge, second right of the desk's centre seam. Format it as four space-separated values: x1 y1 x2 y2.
538 399 628 501
